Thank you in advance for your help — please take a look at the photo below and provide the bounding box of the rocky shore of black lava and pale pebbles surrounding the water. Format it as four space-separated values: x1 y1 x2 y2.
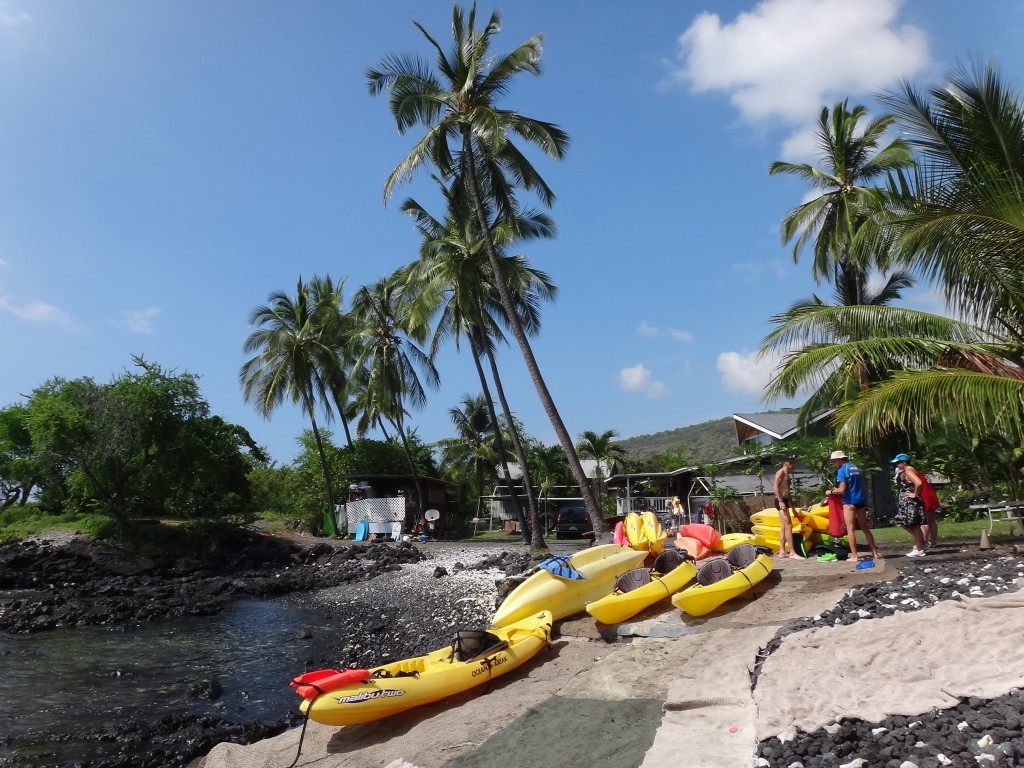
0 531 544 768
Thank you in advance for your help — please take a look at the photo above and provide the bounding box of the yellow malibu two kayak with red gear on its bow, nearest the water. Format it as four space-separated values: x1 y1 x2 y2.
291 611 552 725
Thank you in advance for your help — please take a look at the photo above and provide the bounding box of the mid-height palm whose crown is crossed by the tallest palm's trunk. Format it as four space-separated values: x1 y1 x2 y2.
402 180 557 550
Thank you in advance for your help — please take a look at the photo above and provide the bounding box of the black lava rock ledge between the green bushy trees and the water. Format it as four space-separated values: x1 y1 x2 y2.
0 534 424 633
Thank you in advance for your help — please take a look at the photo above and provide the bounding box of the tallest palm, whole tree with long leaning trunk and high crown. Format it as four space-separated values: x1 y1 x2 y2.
367 5 604 534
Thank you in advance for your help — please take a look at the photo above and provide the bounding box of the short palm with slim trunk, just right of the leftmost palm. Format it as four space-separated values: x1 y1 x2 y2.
350 275 440 520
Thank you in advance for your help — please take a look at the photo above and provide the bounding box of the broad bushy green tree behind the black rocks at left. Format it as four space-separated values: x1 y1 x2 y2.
12 357 263 534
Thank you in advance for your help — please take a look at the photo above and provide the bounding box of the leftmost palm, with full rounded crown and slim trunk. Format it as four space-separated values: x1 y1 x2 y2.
239 275 351 518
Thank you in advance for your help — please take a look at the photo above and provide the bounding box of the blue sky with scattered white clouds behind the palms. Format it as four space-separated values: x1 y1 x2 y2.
0 0 1024 464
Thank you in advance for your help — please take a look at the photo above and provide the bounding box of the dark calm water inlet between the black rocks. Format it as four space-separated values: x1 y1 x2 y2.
0 600 340 766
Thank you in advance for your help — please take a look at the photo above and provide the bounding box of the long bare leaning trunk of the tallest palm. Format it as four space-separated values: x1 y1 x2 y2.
462 132 606 539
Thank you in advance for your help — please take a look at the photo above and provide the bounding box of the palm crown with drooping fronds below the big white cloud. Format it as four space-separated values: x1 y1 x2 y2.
768 101 913 281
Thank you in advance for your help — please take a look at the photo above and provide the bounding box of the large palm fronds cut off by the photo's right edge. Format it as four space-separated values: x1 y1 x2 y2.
837 63 1024 441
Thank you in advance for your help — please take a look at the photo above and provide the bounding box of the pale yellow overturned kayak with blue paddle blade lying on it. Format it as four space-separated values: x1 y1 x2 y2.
490 544 647 627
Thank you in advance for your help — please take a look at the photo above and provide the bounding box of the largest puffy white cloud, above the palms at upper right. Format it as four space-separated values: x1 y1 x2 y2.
675 0 929 158
